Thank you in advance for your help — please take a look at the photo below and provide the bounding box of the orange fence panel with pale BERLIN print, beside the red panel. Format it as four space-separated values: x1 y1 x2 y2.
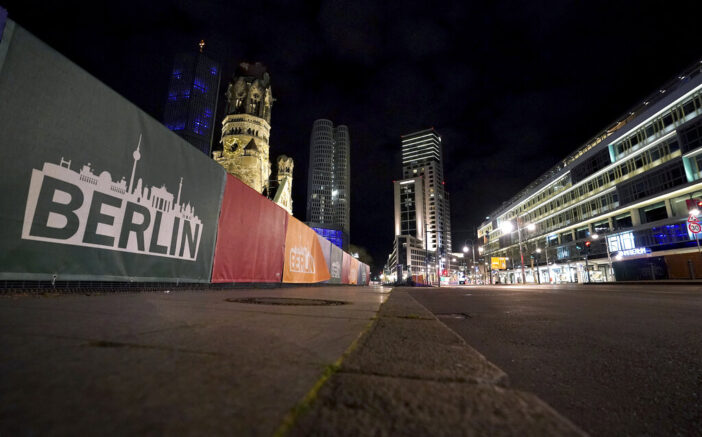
283 216 330 284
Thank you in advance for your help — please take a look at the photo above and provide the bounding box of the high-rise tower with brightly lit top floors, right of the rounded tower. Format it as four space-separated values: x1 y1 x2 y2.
396 128 451 257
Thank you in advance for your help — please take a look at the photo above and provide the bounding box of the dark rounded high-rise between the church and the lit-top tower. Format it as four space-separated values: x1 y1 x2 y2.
307 119 351 248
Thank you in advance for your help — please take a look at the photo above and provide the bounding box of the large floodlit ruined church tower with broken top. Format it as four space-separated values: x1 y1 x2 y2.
213 62 273 192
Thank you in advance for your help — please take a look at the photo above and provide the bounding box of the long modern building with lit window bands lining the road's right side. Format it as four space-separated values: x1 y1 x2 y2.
478 60 702 283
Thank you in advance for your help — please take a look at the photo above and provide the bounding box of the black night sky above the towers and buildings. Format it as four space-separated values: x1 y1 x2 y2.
5 0 702 273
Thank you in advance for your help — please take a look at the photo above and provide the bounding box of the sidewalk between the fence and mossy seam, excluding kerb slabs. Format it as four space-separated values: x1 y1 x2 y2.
0 287 389 436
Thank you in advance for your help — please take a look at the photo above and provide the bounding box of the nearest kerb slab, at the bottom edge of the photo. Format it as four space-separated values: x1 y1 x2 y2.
290 372 582 437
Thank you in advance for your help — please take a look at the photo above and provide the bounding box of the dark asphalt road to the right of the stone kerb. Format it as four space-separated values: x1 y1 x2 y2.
411 285 702 436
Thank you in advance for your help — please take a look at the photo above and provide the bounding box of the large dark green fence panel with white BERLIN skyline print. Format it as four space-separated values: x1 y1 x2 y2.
0 26 225 282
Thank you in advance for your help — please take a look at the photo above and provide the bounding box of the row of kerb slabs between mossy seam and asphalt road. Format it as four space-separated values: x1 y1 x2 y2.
288 288 584 437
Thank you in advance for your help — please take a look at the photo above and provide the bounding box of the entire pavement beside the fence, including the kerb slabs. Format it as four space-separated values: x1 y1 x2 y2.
0 286 582 436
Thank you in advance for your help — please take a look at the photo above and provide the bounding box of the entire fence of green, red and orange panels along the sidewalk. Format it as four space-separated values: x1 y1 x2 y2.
0 20 370 285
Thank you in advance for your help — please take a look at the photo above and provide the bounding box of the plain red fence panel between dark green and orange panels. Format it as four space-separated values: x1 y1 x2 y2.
212 174 288 282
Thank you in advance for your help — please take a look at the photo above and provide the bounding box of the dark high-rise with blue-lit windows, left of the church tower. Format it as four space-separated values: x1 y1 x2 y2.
163 41 220 156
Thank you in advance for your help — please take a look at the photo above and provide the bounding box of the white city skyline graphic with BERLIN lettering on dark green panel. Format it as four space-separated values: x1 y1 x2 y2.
22 135 203 261
